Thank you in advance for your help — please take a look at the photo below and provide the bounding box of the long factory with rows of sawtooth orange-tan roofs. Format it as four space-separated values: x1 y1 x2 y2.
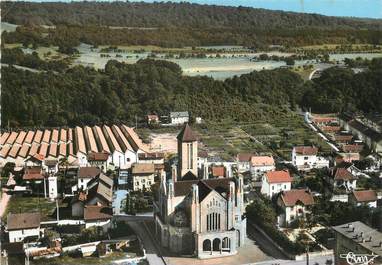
0 125 149 168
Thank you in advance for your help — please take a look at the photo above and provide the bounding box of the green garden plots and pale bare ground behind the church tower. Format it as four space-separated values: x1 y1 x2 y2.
139 112 331 161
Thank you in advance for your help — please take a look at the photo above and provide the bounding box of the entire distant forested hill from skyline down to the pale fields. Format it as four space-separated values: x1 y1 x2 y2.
1 2 382 49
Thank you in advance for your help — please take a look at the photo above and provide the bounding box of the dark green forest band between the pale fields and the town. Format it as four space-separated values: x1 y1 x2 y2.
1 56 382 127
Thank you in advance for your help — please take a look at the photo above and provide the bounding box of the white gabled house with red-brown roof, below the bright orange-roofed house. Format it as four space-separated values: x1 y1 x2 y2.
277 189 314 226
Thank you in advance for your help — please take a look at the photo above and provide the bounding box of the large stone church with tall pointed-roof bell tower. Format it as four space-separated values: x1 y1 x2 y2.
154 124 246 259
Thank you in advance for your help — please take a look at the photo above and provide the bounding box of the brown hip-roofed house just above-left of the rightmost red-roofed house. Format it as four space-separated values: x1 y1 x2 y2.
329 167 358 191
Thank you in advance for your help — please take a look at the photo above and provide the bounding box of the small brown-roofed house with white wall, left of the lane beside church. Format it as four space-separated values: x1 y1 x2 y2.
84 205 113 233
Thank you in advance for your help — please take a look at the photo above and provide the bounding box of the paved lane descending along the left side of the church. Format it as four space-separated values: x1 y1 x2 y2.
129 221 166 265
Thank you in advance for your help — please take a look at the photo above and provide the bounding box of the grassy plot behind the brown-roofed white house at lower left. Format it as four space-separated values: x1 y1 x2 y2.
3 196 56 222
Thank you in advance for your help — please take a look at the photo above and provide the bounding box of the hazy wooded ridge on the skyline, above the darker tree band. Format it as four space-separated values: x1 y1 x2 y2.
1 2 382 29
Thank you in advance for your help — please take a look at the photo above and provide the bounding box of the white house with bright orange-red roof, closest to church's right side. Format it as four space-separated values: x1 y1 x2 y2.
261 170 293 197
